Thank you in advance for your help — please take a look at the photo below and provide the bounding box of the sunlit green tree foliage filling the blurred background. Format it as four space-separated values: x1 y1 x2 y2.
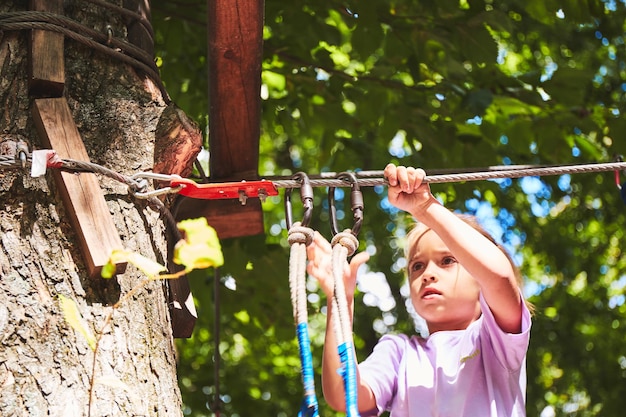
154 0 626 417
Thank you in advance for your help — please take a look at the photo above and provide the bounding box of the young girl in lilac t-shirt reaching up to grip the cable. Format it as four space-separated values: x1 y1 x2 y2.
308 164 530 417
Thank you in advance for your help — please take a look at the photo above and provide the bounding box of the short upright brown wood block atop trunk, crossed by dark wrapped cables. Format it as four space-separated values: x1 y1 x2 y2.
28 0 65 97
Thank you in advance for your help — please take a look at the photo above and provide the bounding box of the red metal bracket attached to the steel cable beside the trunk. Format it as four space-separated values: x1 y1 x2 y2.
170 178 278 204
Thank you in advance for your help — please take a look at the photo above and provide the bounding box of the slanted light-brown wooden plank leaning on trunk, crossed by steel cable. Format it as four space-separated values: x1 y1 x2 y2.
33 98 126 278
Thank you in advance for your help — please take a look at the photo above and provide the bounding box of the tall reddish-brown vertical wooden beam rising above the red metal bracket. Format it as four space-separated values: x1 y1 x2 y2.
207 0 264 180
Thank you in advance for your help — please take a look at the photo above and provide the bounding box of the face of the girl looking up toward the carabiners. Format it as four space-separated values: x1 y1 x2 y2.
408 229 480 333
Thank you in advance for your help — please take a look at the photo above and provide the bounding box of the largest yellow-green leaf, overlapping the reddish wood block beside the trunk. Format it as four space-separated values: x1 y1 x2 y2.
174 217 224 272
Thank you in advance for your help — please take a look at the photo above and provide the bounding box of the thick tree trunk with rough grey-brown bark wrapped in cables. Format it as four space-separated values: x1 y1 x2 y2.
0 1 193 416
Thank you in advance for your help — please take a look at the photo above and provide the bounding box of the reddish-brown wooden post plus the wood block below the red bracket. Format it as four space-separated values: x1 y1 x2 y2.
179 0 265 239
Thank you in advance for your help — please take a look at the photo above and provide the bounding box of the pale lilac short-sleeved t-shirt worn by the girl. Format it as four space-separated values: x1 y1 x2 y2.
359 295 531 417
